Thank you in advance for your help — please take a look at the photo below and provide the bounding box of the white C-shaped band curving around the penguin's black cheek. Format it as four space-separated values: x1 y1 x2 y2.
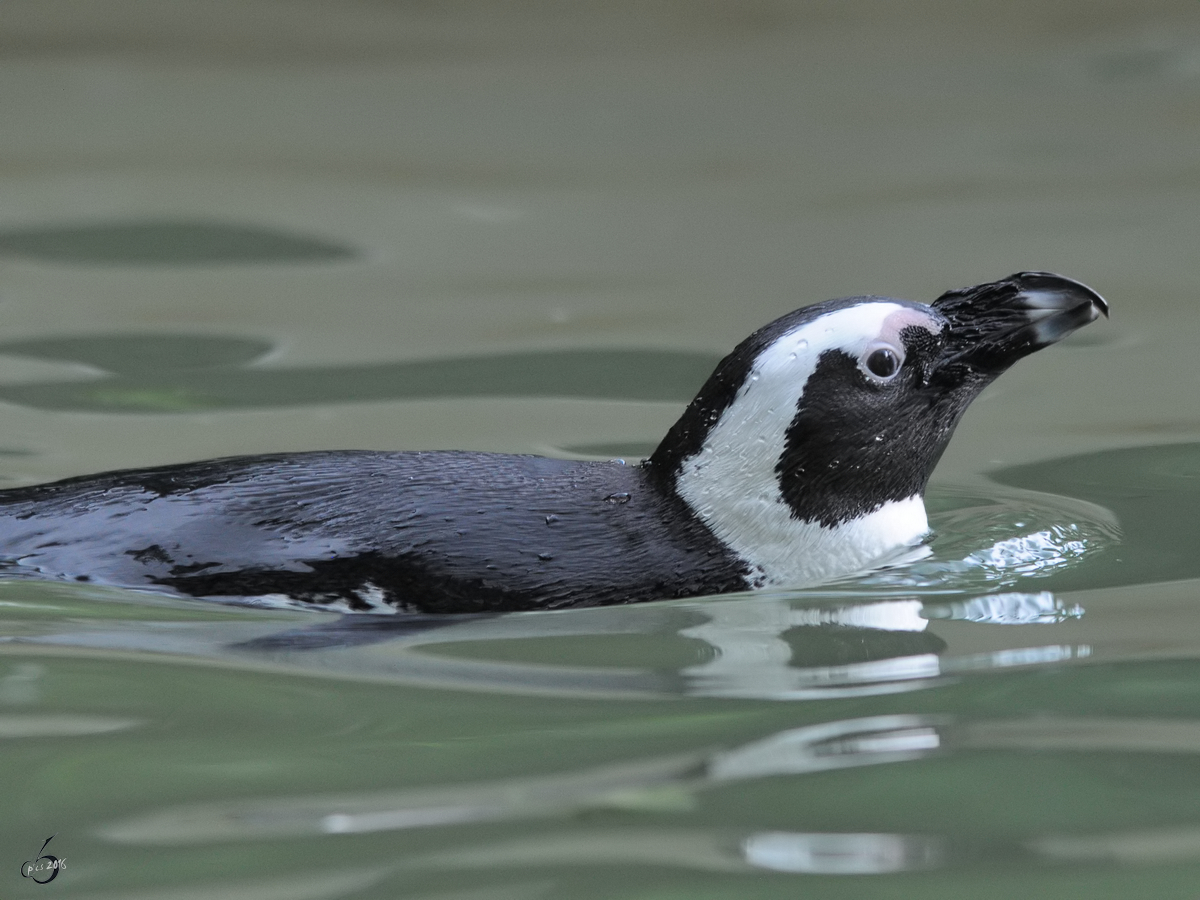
676 301 941 587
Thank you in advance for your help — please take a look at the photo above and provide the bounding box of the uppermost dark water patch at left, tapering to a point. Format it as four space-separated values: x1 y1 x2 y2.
0 218 359 266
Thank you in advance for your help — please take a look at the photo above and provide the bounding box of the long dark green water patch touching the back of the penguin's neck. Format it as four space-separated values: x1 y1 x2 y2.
0 335 719 413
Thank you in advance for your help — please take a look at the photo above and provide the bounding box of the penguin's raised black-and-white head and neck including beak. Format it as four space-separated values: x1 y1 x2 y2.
647 272 1108 583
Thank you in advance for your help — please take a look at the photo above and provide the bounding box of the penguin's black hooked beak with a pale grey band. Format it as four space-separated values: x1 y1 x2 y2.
932 272 1109 384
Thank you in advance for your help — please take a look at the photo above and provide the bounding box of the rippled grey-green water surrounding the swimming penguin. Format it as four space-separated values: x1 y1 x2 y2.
0 0 1200 900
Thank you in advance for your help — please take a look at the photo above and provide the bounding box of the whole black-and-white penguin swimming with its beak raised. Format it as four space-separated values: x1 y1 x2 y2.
0 272 1108 614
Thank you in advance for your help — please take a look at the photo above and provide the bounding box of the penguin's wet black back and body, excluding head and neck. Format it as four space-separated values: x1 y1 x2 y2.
0 451 746 612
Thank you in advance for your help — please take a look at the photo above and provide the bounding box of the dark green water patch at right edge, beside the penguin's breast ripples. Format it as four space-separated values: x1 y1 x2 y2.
990 443 1200 590
